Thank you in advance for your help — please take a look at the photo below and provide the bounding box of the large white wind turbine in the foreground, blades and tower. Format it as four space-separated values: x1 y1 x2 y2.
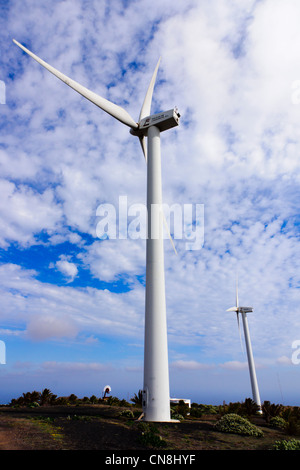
13 39 180 421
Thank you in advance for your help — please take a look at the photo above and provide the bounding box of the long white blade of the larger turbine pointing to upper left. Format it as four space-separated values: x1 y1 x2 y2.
13 39 138 129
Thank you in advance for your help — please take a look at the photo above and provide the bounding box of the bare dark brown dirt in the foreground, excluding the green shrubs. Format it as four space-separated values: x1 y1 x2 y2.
0 405 291 451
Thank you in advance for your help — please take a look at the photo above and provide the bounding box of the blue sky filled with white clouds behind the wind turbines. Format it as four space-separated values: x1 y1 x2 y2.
0 0 300 405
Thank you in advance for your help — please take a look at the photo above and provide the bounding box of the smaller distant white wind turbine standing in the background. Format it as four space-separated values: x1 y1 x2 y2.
226 281 261 413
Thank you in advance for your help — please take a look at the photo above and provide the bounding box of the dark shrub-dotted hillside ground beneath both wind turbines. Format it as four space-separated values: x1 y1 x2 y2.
0 394 300 451
